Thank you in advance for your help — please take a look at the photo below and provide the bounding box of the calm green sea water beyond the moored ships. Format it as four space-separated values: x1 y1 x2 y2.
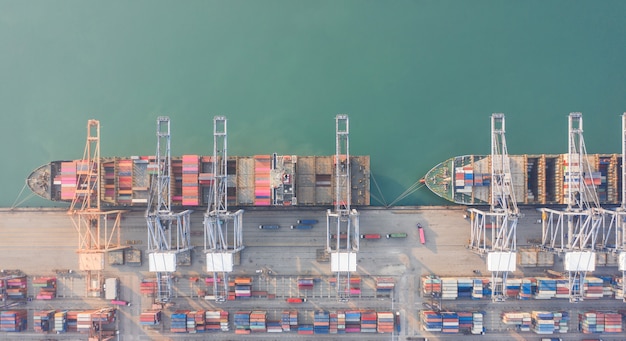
0 0 626 207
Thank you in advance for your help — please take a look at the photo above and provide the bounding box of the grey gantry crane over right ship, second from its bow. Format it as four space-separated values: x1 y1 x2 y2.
540 112 605 302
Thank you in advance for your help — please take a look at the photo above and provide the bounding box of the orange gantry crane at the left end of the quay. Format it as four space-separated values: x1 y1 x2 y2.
68 120 125 297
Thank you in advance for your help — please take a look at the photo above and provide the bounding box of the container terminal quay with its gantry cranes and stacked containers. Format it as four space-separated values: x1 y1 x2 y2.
0 114 626 340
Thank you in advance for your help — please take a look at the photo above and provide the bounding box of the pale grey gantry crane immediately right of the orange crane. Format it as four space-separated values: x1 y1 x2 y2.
146 116 192 303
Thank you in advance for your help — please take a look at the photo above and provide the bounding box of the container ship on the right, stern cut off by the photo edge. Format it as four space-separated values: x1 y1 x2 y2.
422 154 622 205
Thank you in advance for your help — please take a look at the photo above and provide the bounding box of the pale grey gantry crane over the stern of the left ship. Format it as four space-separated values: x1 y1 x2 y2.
326 115 359 301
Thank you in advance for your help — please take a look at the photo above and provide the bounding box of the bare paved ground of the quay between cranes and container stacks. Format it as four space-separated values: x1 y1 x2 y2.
0 207 626 340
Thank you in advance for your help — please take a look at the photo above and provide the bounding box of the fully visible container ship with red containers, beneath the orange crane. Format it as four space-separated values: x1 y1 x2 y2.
26 153 370 207
